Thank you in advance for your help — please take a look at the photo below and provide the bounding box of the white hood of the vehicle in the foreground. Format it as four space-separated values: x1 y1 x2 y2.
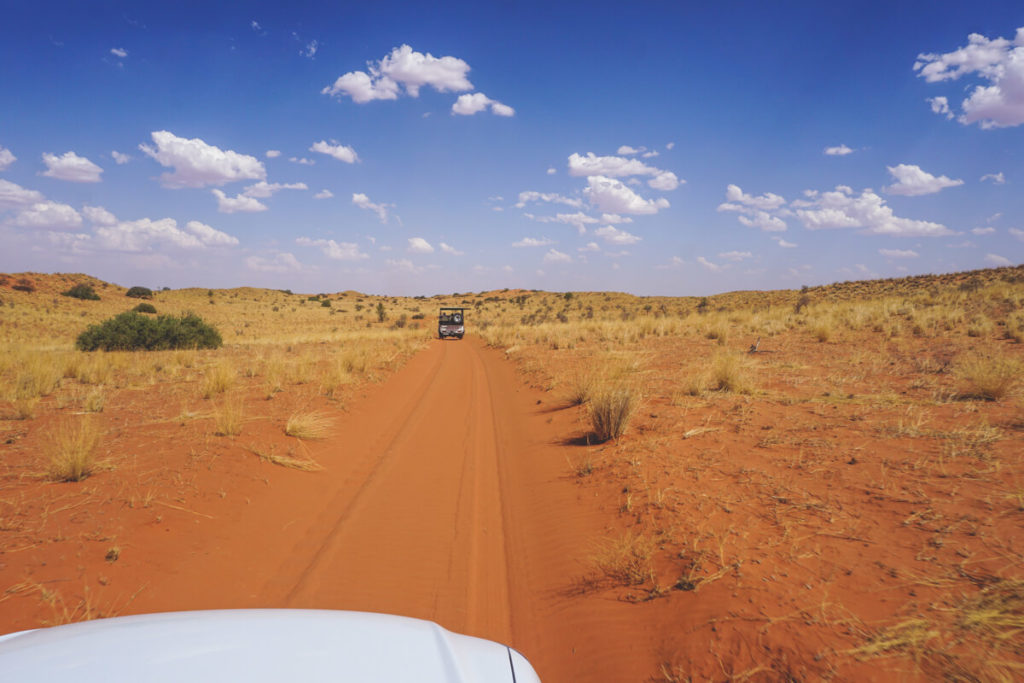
0 609 541 683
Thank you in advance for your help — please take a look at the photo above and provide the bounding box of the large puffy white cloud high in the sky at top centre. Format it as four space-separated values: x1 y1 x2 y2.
321 45 473 104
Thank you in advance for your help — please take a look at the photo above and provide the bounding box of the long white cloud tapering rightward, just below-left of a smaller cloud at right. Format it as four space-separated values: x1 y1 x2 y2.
792 185 952 237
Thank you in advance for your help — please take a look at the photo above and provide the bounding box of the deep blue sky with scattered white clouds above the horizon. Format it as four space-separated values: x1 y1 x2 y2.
0 0 1024 295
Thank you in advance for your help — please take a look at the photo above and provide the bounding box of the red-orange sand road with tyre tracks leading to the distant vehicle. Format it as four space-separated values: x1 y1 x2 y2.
105 338 655 681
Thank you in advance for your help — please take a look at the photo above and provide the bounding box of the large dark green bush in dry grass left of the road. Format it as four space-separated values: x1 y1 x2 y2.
75 310 223 351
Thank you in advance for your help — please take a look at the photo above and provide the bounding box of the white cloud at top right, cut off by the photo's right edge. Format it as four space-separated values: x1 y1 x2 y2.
913 27 1024 128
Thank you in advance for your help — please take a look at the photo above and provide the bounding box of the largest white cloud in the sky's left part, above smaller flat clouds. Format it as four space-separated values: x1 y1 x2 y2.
138 130 266 188
